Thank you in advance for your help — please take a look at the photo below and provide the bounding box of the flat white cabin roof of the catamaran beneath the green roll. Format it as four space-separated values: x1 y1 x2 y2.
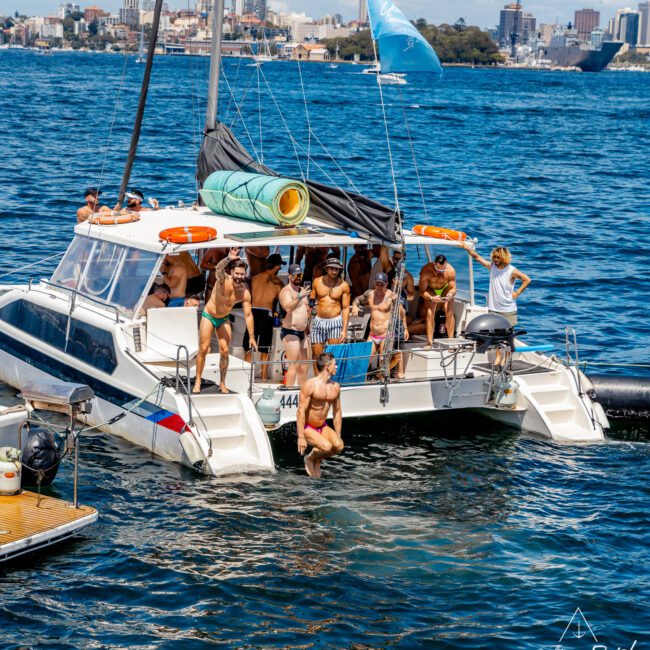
75 207 380 253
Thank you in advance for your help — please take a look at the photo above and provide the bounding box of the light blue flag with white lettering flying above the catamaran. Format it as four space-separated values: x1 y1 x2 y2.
368 0 442 74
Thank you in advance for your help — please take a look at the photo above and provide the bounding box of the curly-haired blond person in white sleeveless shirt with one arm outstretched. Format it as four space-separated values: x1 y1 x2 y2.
462 242 530 327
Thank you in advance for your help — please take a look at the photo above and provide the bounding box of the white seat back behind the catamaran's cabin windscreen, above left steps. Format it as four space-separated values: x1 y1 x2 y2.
138 307 199 363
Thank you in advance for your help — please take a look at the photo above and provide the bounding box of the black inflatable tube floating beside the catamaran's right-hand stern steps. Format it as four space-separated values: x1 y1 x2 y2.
589 375 650 418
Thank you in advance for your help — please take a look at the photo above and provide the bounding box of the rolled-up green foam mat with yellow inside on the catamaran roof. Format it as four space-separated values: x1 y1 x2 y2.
201 171 309 226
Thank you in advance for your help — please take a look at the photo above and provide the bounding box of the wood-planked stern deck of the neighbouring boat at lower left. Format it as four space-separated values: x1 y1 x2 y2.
0 491 97 561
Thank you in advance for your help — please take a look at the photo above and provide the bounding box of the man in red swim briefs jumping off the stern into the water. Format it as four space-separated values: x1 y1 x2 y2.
296 352 343 478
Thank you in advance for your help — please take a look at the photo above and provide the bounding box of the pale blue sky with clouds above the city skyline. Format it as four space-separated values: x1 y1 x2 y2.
10 0 624 27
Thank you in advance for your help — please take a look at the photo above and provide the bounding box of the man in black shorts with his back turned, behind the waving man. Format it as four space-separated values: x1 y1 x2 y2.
242 253 286 381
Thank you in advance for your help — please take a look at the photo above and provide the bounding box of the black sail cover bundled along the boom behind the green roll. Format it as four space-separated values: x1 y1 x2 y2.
196 123 397 242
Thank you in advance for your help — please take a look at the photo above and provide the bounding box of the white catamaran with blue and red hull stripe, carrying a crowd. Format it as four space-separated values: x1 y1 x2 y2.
0 0 608 475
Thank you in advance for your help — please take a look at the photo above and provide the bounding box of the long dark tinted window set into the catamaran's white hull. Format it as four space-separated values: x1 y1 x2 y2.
0 300 117 374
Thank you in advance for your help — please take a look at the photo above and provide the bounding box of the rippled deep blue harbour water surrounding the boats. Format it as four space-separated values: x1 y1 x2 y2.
0 50 650 650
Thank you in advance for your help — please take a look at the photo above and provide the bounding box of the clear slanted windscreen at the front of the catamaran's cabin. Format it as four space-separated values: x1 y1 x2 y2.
51 235 160 314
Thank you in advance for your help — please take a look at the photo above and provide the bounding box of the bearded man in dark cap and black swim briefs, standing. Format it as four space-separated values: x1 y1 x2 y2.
280 264 311 386
